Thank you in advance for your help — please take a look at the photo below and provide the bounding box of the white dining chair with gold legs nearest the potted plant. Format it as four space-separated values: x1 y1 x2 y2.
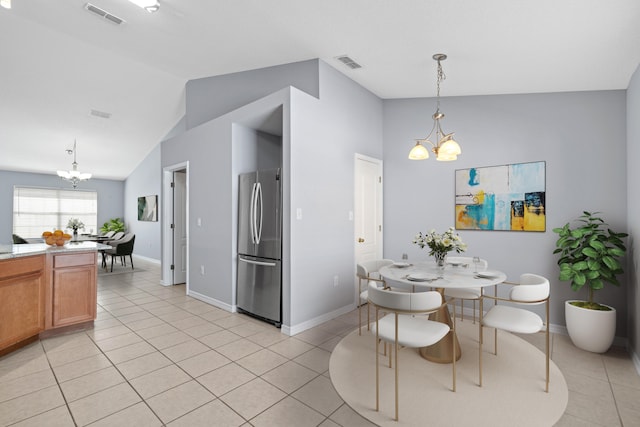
478 273 549 393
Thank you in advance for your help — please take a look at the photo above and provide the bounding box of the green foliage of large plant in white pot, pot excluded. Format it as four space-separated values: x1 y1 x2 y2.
553 211 627 310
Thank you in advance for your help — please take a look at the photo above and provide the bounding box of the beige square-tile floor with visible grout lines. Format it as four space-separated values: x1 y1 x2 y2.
0 260 640 427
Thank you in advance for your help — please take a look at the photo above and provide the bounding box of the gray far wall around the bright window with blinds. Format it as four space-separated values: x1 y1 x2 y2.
0 171 124 243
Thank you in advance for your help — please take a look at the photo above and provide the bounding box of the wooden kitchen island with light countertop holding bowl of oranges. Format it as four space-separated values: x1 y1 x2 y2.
0 242 109 355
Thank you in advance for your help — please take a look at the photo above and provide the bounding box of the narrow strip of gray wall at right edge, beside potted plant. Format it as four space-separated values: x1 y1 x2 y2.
627 67 640 362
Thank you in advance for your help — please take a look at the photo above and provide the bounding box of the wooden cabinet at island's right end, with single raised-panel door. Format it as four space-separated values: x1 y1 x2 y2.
47 252 97 328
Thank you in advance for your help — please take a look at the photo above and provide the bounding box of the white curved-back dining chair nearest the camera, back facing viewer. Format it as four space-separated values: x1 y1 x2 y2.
369 283 456 421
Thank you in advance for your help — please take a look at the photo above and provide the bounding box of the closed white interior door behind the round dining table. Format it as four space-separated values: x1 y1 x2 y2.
354 154 382 277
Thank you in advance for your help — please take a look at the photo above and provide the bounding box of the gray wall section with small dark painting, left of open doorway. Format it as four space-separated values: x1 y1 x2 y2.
124 144 162 262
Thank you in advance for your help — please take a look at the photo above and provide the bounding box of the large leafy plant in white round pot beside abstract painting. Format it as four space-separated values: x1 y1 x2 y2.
553 211 627 353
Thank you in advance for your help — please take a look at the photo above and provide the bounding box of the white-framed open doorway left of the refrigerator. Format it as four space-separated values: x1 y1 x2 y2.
162 162 189 294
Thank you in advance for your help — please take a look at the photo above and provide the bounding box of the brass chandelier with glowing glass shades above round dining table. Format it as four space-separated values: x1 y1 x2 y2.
409 53 462 162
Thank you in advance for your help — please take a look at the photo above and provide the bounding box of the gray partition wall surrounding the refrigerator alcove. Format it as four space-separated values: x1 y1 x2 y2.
162 61 382 331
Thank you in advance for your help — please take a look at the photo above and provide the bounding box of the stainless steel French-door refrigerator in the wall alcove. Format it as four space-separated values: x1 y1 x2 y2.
237 169 282 327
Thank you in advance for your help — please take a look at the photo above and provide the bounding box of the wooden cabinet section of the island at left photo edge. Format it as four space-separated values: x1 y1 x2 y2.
0 255 45 354
